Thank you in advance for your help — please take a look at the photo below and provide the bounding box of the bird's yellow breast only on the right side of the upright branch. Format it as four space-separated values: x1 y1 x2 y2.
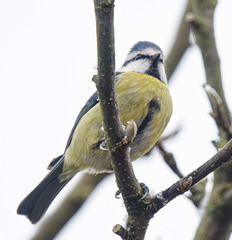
117 72 172 161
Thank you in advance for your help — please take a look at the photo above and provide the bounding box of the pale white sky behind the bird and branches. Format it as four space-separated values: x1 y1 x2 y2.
0 0 232 240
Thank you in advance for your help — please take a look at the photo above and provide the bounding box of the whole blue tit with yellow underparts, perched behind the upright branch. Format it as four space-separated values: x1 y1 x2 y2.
17 41 172 223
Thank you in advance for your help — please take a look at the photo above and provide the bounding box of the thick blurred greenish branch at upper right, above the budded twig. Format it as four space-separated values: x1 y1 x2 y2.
186 0 231 136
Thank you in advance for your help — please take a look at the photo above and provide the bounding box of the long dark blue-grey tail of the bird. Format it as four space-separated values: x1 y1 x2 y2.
17 157 70 223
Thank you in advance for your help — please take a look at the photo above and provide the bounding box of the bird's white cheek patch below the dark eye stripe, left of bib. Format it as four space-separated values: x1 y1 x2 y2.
119 59 150 73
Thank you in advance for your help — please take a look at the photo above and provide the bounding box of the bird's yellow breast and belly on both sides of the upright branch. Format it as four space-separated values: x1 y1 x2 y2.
62 72 172 178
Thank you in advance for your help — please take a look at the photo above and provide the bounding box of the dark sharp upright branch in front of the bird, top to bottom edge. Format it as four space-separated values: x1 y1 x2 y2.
94 0 150 239
